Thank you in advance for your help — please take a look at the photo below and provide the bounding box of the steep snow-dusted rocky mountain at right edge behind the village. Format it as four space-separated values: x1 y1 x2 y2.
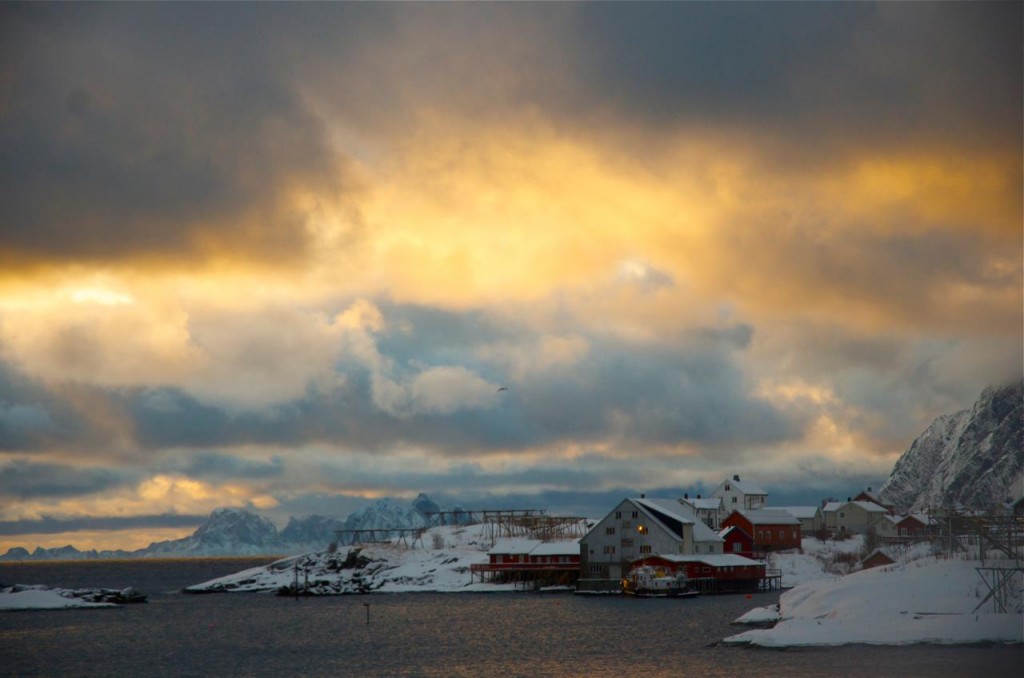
879 381 1024 511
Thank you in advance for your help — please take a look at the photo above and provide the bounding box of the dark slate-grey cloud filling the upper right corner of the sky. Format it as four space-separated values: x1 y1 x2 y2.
572 2 1022 154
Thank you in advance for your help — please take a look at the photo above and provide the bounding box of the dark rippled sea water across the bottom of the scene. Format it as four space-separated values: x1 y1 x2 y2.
0 559 1024 678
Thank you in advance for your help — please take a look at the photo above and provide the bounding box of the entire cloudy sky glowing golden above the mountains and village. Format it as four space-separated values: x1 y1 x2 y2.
0 2 1024 549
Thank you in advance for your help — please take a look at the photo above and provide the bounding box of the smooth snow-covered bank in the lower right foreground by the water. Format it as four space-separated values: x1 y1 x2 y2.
725 557 1024 647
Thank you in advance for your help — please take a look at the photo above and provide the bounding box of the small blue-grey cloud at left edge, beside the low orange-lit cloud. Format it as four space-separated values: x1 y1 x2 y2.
0 461 136 500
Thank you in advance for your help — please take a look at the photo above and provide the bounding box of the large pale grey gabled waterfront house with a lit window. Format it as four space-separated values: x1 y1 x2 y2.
580 496 723 590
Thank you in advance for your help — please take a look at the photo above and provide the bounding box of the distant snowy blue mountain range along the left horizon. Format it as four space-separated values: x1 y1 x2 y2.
0 494 464 560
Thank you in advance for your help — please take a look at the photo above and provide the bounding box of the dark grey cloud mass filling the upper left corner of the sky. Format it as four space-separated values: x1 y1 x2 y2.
0 4 346 266
